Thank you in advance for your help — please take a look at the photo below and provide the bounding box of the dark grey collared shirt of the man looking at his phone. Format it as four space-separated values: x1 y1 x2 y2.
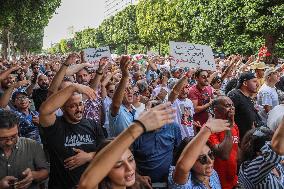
0 137 48 189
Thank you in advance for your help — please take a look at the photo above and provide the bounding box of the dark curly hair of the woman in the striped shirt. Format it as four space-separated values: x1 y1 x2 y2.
240 127 273 163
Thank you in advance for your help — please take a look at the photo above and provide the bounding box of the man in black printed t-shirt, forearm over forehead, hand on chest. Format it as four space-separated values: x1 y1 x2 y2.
40 53 104 189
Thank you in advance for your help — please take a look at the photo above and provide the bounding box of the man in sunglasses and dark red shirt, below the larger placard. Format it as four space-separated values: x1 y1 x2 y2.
188 69 213 125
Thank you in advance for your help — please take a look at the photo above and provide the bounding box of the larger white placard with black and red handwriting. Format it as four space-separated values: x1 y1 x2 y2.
170 41 216 71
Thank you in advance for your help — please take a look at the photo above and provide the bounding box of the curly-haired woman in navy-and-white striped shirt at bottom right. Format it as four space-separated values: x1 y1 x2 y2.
239 117 284 189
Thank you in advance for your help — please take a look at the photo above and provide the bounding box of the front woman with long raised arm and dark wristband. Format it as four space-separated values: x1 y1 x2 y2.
79 103 175 189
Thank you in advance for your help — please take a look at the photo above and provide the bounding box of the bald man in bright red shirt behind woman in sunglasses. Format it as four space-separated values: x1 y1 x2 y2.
206 96 239 189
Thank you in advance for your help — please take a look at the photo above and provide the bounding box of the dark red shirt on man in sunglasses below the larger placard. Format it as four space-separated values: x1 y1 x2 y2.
188 85 213 125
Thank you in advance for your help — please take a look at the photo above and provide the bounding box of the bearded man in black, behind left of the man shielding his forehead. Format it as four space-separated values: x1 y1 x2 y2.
32 74 49 111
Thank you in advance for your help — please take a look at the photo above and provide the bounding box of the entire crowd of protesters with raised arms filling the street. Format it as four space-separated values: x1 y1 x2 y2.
0 47 284 189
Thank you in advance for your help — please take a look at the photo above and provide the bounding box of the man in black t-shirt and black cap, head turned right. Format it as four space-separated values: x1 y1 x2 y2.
228 72 263 139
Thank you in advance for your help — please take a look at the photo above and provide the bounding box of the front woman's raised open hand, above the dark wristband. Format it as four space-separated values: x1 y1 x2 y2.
138 102 176 131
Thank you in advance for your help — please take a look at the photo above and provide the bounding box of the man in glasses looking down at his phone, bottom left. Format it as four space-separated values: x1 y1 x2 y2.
0 110 48 189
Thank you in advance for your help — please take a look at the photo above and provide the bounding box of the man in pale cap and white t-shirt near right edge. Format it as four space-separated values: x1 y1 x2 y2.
257 68 279 122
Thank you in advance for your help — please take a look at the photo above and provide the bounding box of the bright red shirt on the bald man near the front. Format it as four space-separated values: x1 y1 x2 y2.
209 124 239 189
